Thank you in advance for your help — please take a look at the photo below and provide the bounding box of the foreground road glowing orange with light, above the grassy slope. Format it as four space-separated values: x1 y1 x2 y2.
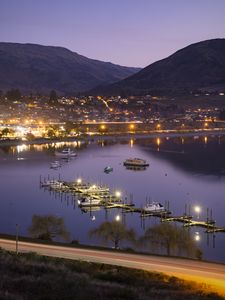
0 239 225 296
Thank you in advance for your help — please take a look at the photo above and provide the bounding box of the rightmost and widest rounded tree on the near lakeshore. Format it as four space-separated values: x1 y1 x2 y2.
140 223 198 257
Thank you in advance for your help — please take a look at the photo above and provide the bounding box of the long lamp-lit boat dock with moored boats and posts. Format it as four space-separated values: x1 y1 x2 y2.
40 176 225 234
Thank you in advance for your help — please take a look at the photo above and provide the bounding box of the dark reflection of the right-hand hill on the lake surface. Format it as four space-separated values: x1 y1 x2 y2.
140 137 225 176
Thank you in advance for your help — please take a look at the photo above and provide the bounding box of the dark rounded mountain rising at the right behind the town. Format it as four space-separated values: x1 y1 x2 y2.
93 39 225 94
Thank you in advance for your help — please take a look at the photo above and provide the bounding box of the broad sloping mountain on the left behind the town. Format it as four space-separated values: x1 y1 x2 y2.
0 43 140 94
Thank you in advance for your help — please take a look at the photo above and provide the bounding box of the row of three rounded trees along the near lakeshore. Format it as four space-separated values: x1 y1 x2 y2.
29 215 202 259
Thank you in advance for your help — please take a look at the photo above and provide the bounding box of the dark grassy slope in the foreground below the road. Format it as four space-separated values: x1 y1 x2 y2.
0 250 224 300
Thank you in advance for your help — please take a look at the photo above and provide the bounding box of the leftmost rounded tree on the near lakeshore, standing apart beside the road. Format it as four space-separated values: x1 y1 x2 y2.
28 215 69 241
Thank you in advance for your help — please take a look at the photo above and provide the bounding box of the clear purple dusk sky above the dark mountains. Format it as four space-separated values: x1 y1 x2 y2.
0 0 225 67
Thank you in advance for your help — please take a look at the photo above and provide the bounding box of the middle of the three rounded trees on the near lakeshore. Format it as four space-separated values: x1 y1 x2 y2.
89 221 135 249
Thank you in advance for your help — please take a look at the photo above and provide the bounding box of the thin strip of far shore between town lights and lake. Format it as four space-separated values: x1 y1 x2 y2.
0 129 225 147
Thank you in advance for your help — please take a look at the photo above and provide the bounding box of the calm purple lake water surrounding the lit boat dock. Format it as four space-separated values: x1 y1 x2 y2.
0 137 225 262
